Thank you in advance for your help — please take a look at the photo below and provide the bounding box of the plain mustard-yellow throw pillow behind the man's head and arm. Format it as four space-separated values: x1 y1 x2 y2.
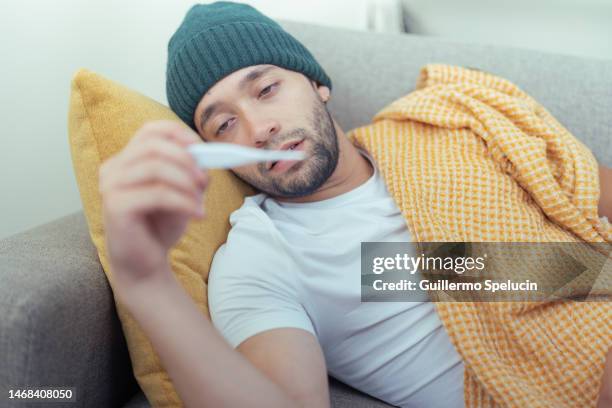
68 69 254 407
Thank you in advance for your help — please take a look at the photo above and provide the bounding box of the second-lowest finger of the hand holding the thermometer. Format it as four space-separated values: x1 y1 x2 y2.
115 159 204 198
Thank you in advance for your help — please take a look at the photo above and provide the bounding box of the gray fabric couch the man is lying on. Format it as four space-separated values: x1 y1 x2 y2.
0 22 612 407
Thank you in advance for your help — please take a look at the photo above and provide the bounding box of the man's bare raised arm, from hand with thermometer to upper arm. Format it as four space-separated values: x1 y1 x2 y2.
99 121 329 408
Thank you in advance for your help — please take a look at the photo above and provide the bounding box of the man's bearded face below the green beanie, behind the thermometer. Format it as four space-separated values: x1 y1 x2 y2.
194 65 338 198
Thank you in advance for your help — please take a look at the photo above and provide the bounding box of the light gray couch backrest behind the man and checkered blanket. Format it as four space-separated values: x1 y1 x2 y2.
281 21 612 166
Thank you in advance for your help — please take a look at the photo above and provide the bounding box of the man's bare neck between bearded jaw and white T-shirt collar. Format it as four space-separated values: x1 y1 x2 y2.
278 121 374 203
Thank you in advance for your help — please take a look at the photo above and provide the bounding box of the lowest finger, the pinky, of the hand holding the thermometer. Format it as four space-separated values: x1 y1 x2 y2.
107 184 204 218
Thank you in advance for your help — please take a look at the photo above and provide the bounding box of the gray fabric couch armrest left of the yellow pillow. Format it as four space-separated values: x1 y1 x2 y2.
0 213 137 407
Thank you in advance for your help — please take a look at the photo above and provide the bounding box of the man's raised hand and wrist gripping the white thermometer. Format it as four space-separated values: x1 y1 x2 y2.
99 121 208 286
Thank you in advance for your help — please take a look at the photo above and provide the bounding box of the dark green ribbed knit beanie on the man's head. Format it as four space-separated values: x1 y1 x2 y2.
166 1 331 130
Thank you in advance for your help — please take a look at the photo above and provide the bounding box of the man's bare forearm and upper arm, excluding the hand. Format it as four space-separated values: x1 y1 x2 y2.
118 266 329 408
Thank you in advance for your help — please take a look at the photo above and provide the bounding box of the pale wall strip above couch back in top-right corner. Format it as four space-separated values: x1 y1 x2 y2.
401 0 612 59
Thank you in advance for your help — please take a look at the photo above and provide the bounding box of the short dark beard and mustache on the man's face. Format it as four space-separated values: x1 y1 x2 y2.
236 95 339 198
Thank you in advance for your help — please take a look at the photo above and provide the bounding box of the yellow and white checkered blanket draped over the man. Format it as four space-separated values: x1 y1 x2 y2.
347 65 612 408
